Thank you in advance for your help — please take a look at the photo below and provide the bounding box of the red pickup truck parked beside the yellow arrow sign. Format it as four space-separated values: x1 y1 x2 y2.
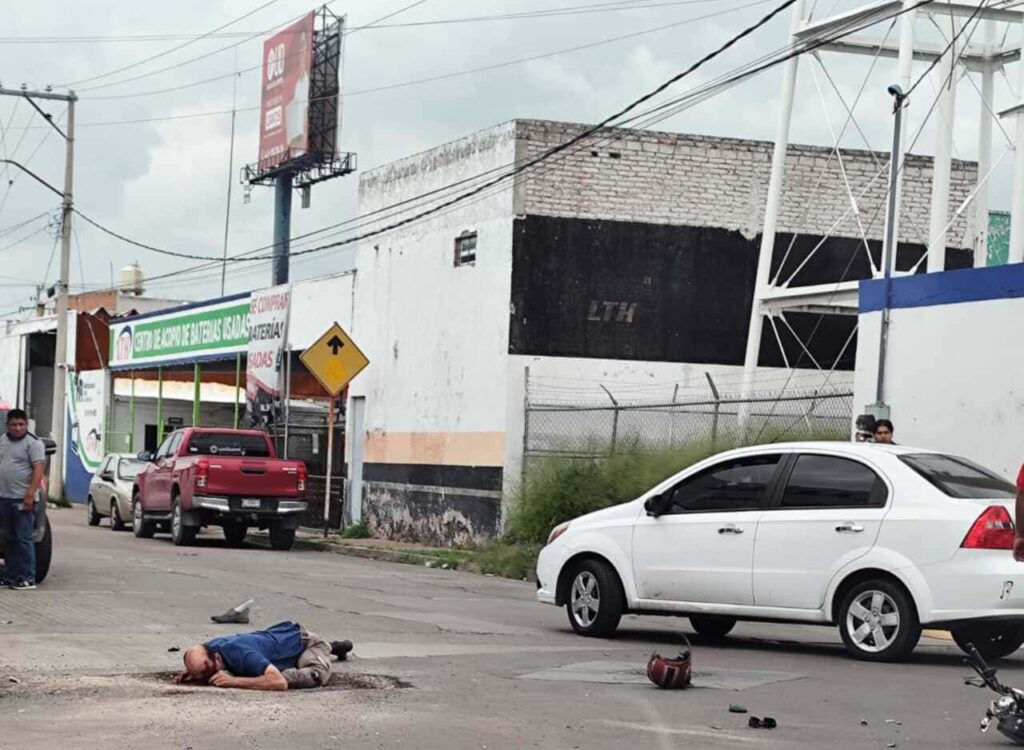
132 427 306 549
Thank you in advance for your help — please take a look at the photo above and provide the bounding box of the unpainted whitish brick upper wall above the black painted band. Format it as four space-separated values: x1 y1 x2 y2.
516 120 978 247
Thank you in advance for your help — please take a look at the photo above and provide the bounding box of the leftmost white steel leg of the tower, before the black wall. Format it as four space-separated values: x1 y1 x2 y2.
739 0 804 432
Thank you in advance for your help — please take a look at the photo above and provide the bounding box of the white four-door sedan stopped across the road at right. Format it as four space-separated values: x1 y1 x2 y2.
537 443 1024 661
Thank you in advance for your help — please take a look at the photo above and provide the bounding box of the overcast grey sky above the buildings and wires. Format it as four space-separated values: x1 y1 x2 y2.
0 0 1020 314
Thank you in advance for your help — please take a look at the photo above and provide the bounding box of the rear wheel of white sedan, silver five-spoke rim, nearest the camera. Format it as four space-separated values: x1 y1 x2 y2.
839 579 921 662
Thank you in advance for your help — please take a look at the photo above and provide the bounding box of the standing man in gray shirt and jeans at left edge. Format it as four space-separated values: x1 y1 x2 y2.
0 409 46 591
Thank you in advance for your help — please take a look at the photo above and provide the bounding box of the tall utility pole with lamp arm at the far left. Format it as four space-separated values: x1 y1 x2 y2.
0 88 78 500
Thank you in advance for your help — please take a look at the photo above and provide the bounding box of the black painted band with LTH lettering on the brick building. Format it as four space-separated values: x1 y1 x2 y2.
509 216 971 370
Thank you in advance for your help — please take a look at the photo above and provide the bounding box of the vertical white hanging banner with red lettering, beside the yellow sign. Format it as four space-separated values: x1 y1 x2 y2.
246 285 292 429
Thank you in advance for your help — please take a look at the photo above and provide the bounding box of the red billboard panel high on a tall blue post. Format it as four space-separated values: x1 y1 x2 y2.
259 12 315 170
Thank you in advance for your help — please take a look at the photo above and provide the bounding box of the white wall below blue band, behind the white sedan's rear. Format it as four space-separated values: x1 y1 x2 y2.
854 266 1024 480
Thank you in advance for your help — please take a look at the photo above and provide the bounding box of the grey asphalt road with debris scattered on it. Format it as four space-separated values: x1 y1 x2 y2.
0 509 1024 750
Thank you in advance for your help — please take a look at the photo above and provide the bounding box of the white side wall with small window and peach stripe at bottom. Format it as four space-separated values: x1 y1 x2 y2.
350 123 515 466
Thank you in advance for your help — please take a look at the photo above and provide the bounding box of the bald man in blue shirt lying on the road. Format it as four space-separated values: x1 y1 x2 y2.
174 622 352 691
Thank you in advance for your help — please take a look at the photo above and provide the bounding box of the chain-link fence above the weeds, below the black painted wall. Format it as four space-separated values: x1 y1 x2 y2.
523 383 853 471
